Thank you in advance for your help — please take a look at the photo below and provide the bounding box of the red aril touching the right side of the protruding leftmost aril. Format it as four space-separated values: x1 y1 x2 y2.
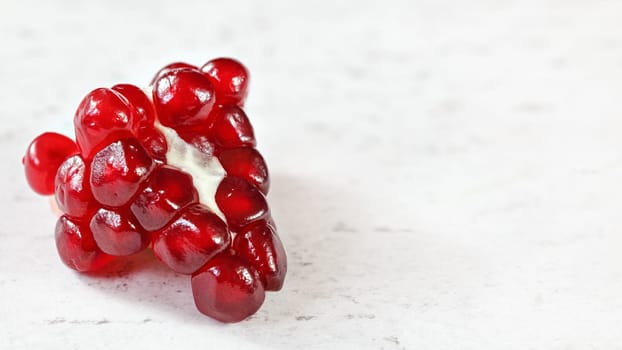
55 155 94 218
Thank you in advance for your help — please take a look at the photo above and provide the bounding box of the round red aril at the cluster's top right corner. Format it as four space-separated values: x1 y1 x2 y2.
201 58 249 106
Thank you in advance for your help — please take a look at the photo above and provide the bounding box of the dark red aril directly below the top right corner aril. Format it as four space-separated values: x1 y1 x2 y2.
210 105 256 148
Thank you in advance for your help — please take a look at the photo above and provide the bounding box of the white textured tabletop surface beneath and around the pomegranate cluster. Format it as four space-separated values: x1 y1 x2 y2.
0 0 622 350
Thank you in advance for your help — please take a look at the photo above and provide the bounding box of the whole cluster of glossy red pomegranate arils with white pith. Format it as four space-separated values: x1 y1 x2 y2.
23 58 287 322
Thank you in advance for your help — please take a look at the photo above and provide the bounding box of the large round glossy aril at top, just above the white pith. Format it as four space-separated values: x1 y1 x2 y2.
153 69 215 129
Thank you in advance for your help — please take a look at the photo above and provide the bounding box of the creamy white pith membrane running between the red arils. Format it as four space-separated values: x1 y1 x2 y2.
144 87 227 223
